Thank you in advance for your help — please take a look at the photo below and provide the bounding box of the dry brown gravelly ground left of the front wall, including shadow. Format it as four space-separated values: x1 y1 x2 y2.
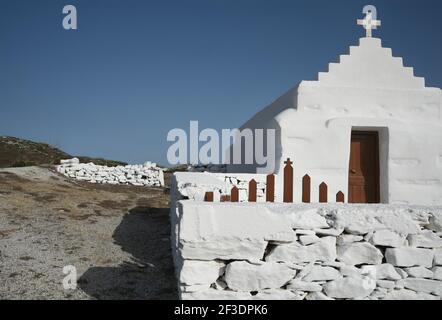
0 167 177 299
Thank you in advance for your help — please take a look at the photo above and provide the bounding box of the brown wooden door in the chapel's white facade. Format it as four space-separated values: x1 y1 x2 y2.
348 131 379 203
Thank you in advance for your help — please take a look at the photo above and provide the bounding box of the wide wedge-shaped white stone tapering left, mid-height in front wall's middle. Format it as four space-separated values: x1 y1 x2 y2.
266 237 336 263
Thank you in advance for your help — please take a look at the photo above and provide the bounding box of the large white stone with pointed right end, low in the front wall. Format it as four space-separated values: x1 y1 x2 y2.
224 261 296 292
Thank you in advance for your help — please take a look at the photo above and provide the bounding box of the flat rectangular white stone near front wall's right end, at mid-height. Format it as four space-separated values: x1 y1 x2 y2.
385 248 434 268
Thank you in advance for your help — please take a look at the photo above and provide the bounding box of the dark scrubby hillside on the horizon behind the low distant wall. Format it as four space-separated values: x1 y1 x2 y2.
0 136 126 168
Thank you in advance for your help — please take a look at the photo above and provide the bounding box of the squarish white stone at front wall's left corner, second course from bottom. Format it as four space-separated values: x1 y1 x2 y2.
180 260 225 285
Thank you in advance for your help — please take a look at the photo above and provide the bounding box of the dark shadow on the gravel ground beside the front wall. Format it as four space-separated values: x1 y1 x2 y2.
78 207 178 300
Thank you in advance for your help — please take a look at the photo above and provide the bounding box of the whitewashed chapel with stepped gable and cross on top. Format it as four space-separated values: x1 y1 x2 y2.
228 12 442 205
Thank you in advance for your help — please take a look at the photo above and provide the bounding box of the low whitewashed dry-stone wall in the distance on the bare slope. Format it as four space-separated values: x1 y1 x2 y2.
57 158 164 187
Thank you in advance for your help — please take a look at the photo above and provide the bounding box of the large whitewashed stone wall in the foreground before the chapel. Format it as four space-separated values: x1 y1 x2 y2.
171 175 442 300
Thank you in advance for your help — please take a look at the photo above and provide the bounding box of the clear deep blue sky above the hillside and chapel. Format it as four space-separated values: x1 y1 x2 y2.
0 0 442 164
